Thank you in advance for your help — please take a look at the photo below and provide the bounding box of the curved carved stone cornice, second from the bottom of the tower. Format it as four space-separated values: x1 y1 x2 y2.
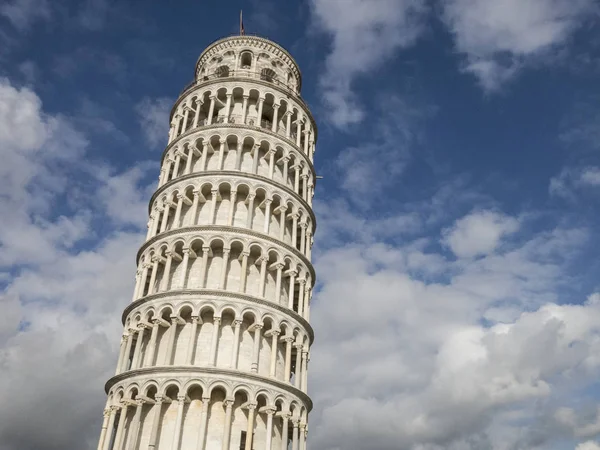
121 288 315 345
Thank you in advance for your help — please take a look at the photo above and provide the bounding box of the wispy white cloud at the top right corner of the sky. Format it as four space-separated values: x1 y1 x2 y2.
443 0 595 91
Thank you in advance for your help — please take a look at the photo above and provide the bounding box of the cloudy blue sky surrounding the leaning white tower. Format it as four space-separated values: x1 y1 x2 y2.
0 0 600 450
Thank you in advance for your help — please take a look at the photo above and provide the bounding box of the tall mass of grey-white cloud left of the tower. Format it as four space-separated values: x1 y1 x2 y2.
0 80 147 450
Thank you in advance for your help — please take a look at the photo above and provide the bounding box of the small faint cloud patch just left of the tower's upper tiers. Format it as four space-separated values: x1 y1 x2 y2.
135 97 173 150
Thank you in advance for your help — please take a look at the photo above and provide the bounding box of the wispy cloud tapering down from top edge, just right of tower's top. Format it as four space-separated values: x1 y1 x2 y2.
310 0 427 127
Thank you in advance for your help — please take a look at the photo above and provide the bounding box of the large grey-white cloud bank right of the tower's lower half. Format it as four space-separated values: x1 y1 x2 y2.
310 199 600 450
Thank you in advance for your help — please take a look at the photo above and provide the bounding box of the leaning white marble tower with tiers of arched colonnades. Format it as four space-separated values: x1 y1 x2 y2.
98 36 317 450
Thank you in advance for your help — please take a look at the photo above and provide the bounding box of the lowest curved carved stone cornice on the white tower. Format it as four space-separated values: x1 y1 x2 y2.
104 366 313 412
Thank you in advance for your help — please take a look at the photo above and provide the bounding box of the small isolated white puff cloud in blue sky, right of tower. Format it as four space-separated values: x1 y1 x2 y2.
443 211 519 258
